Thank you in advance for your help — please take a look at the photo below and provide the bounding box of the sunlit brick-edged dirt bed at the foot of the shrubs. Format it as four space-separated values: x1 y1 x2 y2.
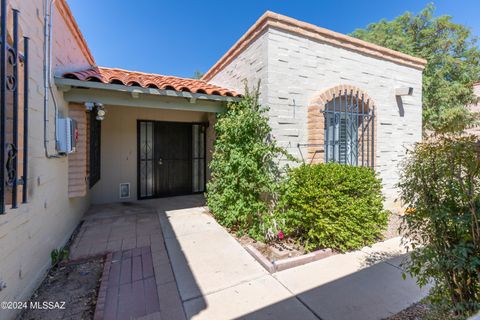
232 234 305 262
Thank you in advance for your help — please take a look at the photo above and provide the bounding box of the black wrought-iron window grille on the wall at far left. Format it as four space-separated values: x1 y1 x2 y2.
0 0 28 214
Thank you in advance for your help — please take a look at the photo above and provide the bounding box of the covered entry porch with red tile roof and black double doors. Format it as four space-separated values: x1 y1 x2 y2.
55 68 239 204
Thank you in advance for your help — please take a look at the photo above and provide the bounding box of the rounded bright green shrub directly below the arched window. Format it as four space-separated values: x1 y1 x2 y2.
276 163 387 251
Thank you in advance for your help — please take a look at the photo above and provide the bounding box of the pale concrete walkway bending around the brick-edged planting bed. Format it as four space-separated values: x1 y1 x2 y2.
152 196 427 320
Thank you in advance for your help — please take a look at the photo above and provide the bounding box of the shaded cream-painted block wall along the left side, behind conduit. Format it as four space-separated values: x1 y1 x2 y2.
0 0 93 319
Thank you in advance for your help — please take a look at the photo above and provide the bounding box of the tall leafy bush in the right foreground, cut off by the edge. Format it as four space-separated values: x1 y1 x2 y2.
399 135 480 317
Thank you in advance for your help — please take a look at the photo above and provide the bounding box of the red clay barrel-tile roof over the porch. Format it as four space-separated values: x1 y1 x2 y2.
63 67 240 97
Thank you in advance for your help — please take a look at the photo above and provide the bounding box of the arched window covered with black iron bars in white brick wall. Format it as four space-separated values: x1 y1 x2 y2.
321 90 375 167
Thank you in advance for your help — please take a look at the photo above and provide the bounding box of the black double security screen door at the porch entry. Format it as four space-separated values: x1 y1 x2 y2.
138 120 205 199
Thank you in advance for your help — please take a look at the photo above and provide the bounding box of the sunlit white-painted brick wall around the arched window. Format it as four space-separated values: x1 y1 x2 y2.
211 28 422 207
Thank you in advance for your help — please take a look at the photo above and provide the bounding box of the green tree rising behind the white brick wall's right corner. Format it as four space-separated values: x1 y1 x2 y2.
352 4 480 132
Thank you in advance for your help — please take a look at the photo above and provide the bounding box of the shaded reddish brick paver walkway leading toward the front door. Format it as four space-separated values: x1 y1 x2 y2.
70 203 185 320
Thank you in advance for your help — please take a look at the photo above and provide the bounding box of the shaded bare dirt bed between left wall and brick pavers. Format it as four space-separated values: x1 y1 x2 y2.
19 257 104 320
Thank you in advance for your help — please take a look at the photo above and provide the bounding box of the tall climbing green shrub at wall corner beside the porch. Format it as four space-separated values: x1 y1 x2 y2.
207 86 289 238
